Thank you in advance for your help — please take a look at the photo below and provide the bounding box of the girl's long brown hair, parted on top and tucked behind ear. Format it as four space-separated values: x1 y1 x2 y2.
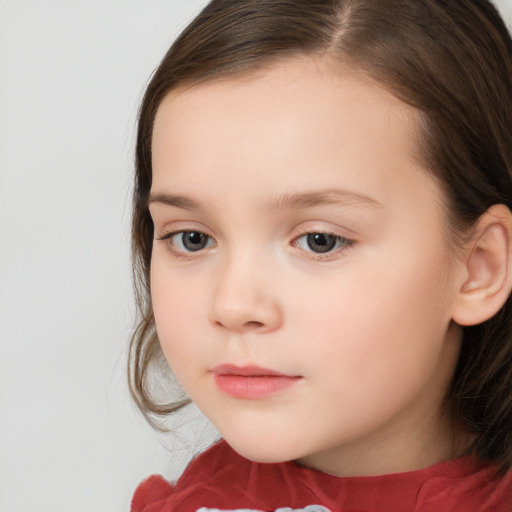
129 0 512 470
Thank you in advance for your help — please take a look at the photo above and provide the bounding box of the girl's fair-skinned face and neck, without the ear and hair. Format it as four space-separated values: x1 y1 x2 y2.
150 58 460 474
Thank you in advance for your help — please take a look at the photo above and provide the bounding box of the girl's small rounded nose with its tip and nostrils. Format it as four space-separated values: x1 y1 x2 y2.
210 255 283 333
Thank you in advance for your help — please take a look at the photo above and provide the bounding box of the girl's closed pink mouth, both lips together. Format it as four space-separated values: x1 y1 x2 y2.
211 364 302 400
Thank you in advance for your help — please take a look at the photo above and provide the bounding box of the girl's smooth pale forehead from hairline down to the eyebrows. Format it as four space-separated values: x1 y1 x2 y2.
152 57 438 214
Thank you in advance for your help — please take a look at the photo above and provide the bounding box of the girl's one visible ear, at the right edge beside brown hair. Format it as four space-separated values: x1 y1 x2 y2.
452 204 512 325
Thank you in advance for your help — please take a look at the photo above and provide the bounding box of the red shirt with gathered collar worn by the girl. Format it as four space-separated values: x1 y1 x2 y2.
131 441 512 512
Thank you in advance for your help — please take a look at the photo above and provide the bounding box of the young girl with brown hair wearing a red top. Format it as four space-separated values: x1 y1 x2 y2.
130 0 512 512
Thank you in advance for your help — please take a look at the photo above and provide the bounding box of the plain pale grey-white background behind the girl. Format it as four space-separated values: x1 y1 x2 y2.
0 0 512 512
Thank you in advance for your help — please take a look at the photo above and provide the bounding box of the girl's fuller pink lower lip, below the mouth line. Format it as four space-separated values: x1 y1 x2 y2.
213 373 300 400
